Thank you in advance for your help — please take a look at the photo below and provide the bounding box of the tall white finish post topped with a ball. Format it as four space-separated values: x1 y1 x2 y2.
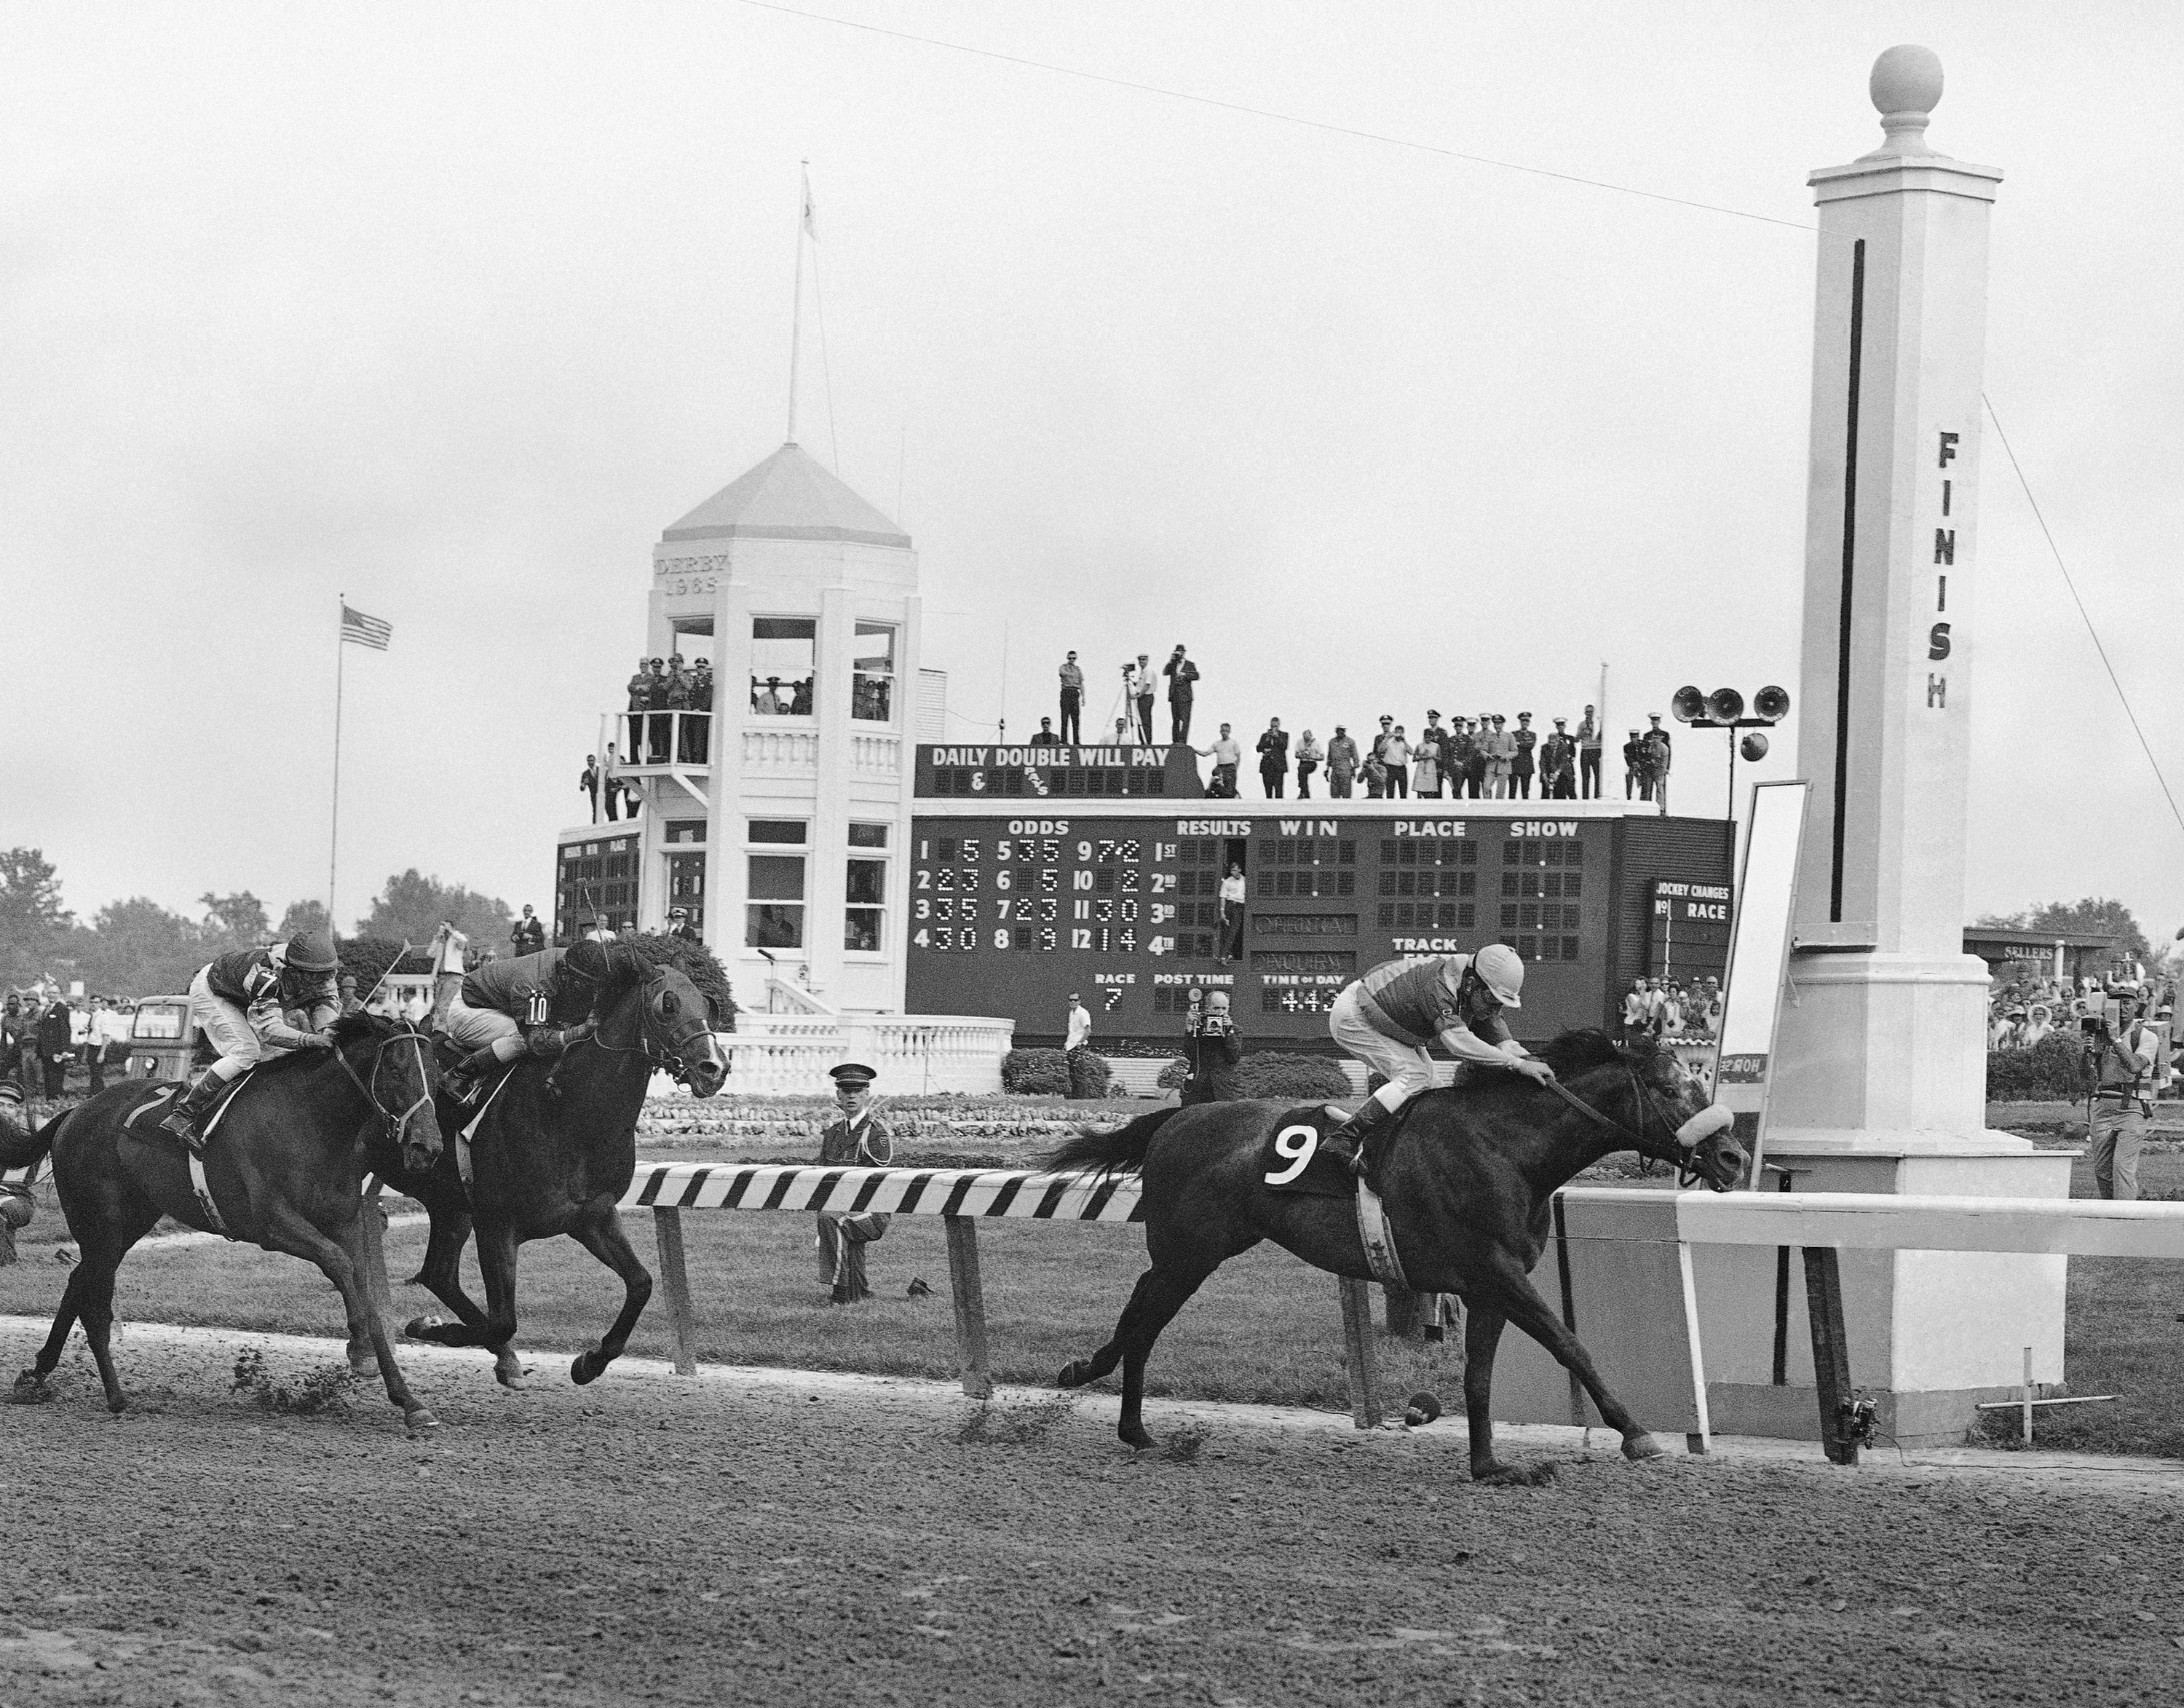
1701 46 2070 1444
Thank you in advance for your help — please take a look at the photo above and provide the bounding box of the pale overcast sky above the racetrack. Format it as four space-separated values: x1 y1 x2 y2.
0 0 2184 937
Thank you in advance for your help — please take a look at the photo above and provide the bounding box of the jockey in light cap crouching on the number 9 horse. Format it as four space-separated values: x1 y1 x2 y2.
1326 944 1555 1175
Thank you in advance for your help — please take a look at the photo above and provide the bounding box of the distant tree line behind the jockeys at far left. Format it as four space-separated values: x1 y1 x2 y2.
0 847 511 996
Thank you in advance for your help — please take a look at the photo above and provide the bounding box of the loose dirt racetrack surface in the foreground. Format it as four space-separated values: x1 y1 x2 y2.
12 1330 2184 1708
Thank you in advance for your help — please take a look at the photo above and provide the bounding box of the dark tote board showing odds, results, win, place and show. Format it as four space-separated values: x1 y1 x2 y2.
906 747 1730 1042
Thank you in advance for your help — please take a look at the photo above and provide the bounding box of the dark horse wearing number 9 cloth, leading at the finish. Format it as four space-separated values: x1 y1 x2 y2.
1046 1031 1745 1483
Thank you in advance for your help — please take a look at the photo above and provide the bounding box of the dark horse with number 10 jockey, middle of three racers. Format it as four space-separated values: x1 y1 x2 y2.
393 944 727 1387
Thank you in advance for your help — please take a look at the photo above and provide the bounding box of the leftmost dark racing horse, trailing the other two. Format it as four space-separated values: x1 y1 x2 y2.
0 1013 441 1433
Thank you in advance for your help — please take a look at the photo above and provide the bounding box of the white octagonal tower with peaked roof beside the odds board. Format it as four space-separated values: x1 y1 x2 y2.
555 441 939 1013
